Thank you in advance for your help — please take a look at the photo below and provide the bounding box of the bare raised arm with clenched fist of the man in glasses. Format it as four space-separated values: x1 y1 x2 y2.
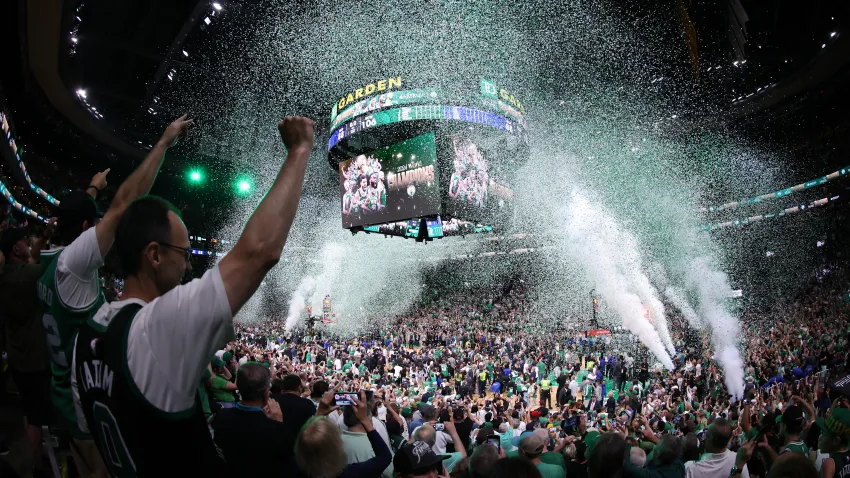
218 116 314 315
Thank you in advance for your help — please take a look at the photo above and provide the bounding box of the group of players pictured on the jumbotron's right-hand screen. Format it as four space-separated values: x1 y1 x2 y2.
449 136 490 208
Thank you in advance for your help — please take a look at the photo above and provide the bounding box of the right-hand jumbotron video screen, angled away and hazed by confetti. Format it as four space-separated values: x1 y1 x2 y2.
445 135 513 221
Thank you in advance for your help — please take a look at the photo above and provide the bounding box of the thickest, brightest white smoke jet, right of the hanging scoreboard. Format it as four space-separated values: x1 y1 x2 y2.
565 191 673 370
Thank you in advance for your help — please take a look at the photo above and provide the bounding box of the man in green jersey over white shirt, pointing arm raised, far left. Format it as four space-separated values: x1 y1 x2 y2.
38 115 192 476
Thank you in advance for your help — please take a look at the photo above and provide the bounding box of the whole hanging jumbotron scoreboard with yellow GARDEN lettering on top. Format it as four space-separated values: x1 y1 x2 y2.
328 76 528 240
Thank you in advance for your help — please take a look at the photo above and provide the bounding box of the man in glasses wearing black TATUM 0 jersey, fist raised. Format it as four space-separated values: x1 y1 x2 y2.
73 117 314 476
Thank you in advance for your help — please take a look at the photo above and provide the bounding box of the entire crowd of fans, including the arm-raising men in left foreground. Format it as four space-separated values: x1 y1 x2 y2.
0 113 850 478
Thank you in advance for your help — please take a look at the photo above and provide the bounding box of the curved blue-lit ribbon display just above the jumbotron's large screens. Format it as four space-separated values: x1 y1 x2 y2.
328 105 524 150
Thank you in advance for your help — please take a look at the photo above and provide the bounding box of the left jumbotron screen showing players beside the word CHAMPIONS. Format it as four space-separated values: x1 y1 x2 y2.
339 133 441 229
